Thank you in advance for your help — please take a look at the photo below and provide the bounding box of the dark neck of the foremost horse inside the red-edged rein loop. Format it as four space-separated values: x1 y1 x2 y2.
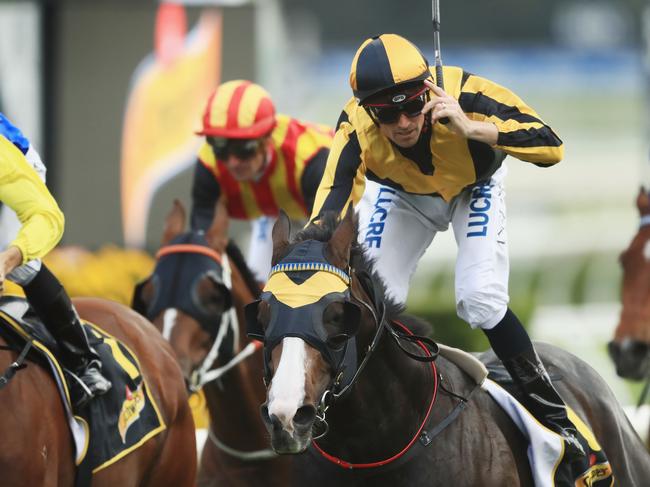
322 334 442 459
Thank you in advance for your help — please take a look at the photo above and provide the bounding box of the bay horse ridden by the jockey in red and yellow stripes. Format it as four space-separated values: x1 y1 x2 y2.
134 201 290 487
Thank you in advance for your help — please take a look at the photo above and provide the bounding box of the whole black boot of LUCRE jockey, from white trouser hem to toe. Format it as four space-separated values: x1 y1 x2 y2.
484 309 586 462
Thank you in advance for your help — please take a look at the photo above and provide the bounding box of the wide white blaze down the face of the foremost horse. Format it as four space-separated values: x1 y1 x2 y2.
268 337 307 433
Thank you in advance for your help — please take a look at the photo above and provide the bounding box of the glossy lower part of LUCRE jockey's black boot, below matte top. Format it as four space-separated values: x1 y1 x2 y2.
503 348 586 462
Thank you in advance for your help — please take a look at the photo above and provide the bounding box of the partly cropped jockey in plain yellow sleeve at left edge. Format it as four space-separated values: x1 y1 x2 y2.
0 113 111 408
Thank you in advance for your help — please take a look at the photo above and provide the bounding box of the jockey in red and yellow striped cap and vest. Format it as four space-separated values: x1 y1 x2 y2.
186 80 333 282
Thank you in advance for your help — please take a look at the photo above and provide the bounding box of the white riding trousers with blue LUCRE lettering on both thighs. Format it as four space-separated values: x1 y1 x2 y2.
357 165 509 329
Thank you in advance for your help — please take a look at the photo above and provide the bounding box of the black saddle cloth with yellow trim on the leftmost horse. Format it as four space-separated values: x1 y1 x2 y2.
0 296 166 487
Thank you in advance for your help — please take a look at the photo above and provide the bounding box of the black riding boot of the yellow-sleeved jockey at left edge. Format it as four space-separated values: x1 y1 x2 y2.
24 265 112 408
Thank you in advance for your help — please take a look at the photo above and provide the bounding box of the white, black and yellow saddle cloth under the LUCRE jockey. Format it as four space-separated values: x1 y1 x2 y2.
440 345 614 487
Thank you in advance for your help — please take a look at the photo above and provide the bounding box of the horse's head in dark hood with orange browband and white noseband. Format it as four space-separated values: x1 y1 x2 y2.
133 200 254 391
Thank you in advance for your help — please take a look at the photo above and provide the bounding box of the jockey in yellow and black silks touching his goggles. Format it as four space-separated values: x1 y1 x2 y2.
311 34 604 484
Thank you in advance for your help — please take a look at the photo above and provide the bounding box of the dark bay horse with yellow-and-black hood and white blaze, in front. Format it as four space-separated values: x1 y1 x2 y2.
246 210 650 487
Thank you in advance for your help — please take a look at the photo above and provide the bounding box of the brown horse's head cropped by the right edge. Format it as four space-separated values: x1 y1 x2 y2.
609 188 650 380
